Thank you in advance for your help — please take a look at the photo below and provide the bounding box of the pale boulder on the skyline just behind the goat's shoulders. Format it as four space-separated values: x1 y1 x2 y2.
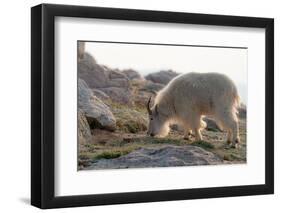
145 70 179 85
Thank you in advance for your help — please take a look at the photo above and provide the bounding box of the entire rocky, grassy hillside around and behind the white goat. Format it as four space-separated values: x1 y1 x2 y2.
78 42 246 170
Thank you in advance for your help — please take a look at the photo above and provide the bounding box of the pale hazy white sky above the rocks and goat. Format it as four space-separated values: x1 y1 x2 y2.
86 42 247 103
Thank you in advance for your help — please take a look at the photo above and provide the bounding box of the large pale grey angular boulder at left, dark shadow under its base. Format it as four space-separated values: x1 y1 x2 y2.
78 79 116 130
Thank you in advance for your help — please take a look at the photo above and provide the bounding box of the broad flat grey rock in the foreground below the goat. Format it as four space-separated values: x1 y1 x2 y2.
85 145 223 169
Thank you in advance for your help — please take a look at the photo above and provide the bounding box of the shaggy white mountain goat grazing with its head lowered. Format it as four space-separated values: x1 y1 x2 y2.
147 73 240 147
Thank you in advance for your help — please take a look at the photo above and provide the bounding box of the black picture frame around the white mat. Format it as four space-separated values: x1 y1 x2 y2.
31 4 274 209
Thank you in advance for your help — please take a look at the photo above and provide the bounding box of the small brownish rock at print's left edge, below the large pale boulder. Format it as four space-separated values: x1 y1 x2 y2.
78 109 92 144
